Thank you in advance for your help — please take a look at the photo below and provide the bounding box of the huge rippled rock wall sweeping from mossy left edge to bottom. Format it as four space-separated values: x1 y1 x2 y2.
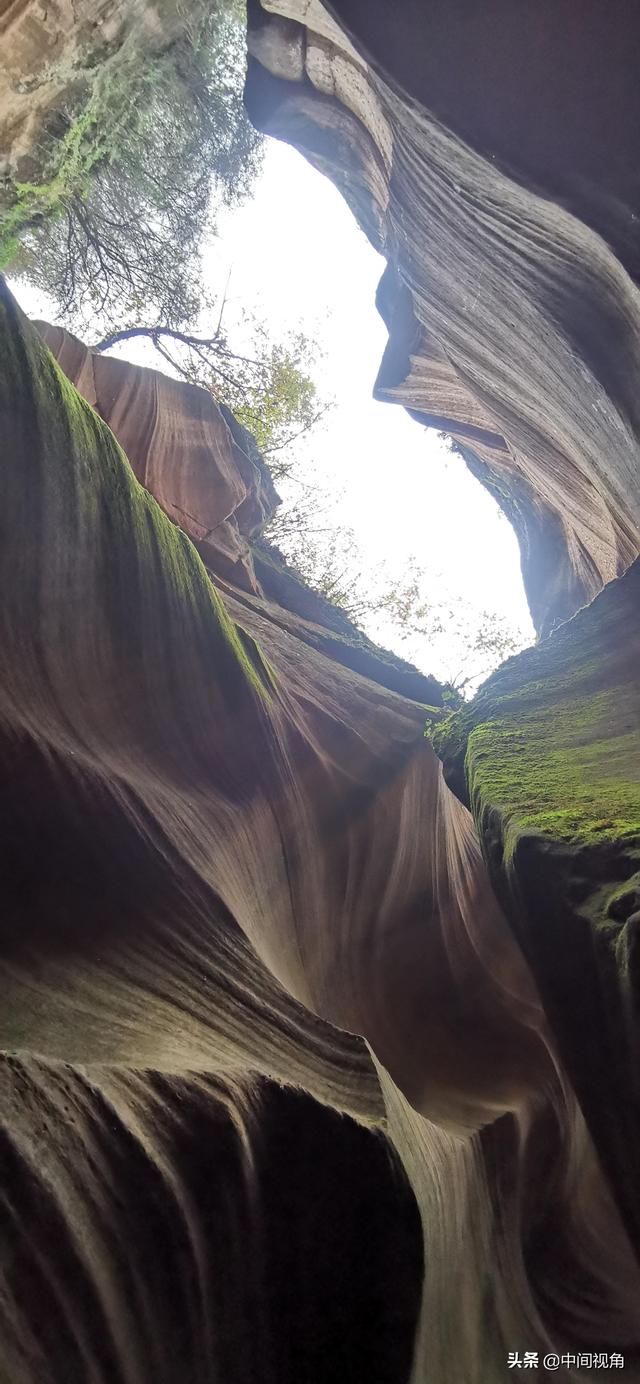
0 291 640 1384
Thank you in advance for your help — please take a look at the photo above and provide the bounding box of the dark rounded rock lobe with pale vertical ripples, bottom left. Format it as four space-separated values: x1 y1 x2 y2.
0 1059 421 1384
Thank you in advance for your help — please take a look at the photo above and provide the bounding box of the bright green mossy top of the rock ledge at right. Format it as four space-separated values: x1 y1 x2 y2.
435 569 640 864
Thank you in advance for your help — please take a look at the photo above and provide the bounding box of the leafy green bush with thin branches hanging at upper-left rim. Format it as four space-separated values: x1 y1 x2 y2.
10 0 262 335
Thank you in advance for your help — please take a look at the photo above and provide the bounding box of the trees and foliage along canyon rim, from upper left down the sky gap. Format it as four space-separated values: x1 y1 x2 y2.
0 0 519 693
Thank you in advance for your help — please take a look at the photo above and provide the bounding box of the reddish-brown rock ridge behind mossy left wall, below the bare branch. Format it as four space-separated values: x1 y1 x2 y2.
35 322 442 707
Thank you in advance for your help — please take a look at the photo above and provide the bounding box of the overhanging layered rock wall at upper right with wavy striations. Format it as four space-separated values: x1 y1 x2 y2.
247 0 640 632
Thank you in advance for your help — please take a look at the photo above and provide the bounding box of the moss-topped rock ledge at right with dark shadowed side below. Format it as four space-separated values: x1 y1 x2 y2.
434 562 640 1237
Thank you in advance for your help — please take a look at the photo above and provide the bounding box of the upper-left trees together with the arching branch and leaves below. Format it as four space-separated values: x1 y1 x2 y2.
7 0 338 492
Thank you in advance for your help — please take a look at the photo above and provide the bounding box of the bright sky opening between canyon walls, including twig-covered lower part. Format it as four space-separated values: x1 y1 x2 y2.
12 136 535 696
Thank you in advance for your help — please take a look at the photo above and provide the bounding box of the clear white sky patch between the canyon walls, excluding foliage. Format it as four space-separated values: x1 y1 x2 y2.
12 140 533 678
